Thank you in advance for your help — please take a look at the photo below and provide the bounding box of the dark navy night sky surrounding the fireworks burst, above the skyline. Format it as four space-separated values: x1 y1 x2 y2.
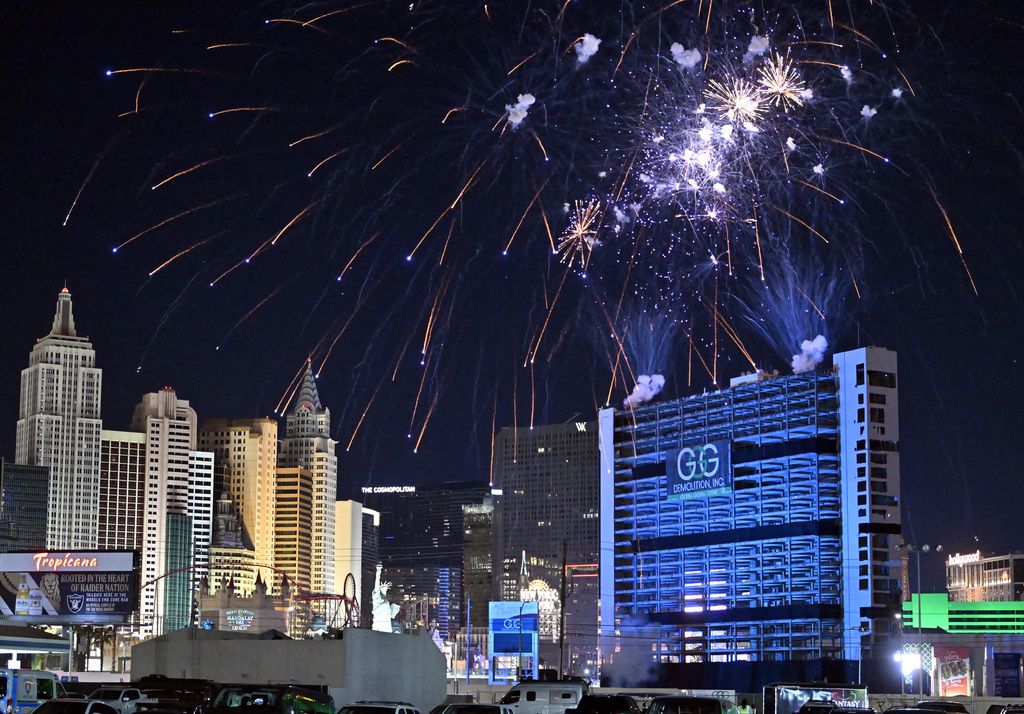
0 0 1024 585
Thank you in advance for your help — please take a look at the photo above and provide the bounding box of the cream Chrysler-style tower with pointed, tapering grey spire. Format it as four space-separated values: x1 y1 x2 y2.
280 362 338 593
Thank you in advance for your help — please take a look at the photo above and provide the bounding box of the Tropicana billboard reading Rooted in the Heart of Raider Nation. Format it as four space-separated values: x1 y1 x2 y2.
0 550 138 625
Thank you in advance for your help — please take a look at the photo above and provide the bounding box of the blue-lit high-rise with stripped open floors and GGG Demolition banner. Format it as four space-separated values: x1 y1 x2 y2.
600 347 900 691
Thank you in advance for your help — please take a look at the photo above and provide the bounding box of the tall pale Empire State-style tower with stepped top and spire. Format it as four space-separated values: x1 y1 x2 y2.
14 288 102 550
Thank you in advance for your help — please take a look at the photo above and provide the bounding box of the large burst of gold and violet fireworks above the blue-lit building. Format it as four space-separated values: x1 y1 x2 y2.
101 0 973 456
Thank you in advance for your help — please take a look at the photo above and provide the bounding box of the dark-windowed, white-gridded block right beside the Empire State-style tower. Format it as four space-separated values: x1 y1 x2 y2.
96 429 146 551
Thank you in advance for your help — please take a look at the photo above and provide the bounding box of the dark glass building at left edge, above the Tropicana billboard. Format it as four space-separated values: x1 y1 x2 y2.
0 459 50 553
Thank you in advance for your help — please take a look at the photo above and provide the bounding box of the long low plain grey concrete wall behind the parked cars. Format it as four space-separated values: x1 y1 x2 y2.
131 628 445 714
